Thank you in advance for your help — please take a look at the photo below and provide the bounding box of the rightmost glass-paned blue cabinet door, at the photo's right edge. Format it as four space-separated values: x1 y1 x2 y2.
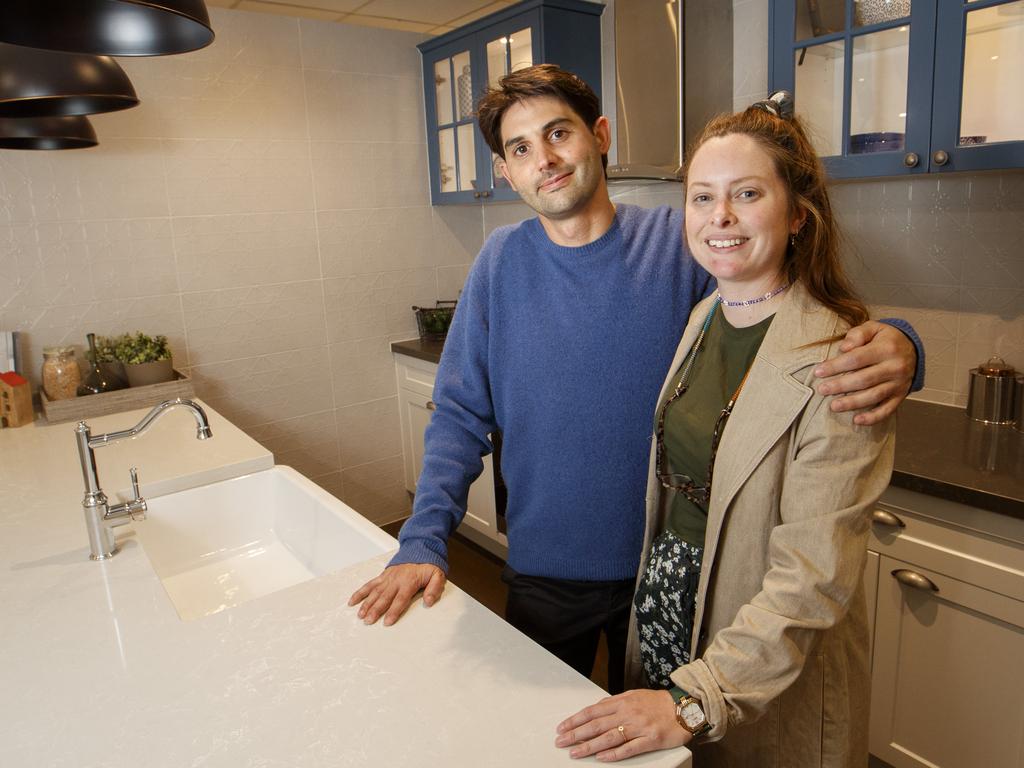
931 0 1024 170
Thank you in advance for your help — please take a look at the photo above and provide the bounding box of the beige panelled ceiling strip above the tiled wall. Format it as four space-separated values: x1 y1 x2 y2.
206 0 515 35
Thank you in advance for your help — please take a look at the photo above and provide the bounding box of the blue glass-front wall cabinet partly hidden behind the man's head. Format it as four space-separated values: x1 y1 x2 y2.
418 0 604 205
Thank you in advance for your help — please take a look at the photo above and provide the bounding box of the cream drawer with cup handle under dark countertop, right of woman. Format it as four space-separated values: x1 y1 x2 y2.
868 504 1024 600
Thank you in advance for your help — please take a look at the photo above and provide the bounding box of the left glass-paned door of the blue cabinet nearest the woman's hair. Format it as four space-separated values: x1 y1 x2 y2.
772 0 935 177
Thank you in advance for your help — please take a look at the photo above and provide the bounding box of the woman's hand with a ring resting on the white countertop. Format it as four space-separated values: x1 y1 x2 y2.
555 690 691 763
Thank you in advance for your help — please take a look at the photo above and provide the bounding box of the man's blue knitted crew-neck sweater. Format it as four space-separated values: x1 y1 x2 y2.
391 205 924 581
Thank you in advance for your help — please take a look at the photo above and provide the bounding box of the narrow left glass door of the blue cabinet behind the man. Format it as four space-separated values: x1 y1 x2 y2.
431 50 476 193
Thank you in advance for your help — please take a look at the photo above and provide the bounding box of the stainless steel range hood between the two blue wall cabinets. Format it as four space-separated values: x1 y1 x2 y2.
608 0 732 181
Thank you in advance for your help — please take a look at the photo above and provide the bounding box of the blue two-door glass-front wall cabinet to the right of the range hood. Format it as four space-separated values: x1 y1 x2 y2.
769 0 1024 178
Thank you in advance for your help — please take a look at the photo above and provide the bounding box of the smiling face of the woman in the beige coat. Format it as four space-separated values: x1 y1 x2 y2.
685 133 804 290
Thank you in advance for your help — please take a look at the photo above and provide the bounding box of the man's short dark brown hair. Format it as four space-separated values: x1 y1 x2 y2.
476 65 608 167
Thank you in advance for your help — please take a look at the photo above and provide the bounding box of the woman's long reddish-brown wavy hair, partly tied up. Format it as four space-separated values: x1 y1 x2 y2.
685 105 868 327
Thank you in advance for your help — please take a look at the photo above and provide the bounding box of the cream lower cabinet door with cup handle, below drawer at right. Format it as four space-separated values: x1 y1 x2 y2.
870 555 1024 768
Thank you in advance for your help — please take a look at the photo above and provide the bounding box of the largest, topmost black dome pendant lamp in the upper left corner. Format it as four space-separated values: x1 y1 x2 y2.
0 0 213 56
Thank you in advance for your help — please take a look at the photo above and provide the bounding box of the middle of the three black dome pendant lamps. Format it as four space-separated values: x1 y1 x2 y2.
0 43 138 118
